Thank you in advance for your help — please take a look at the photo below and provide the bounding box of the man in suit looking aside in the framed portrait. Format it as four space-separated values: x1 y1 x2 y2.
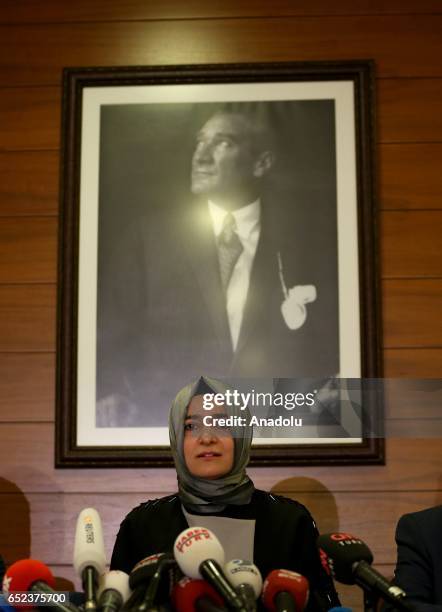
97 107 339 426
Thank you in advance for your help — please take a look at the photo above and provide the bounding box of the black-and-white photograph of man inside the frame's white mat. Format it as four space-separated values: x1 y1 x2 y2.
97 100 339 427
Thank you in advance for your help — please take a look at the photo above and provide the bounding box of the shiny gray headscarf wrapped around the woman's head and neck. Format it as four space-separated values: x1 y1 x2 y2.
169 376 254 514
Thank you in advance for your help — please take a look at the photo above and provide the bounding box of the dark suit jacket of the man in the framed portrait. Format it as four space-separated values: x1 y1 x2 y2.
97 197 339 426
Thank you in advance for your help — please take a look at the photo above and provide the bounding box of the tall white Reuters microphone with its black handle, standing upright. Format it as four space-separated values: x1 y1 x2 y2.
74 508 106 612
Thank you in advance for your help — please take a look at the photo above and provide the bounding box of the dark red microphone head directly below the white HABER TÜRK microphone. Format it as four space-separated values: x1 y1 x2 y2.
172 576 225 612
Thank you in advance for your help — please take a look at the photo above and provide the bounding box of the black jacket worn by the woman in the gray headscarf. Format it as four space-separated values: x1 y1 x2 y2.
111 490 340 610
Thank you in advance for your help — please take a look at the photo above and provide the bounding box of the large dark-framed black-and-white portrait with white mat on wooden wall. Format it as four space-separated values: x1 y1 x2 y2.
56 60 383 467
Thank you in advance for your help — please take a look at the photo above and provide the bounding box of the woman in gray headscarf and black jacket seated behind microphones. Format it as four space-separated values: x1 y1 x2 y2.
111 377 340 610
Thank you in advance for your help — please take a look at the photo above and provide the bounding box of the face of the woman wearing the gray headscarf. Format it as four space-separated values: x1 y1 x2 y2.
184 395 234 480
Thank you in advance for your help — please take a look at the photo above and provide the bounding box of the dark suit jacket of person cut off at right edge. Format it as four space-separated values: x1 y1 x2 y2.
394 506 442 612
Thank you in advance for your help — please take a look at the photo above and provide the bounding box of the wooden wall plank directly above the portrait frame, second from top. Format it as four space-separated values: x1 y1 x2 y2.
0 15 442 86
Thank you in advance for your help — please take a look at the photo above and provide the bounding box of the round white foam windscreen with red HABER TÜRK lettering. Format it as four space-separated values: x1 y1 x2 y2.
173 527 225 579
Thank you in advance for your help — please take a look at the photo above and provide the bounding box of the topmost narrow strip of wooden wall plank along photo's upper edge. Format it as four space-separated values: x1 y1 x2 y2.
0 0 441 23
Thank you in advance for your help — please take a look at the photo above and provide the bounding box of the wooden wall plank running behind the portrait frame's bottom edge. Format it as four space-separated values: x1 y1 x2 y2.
0 423 442 497
